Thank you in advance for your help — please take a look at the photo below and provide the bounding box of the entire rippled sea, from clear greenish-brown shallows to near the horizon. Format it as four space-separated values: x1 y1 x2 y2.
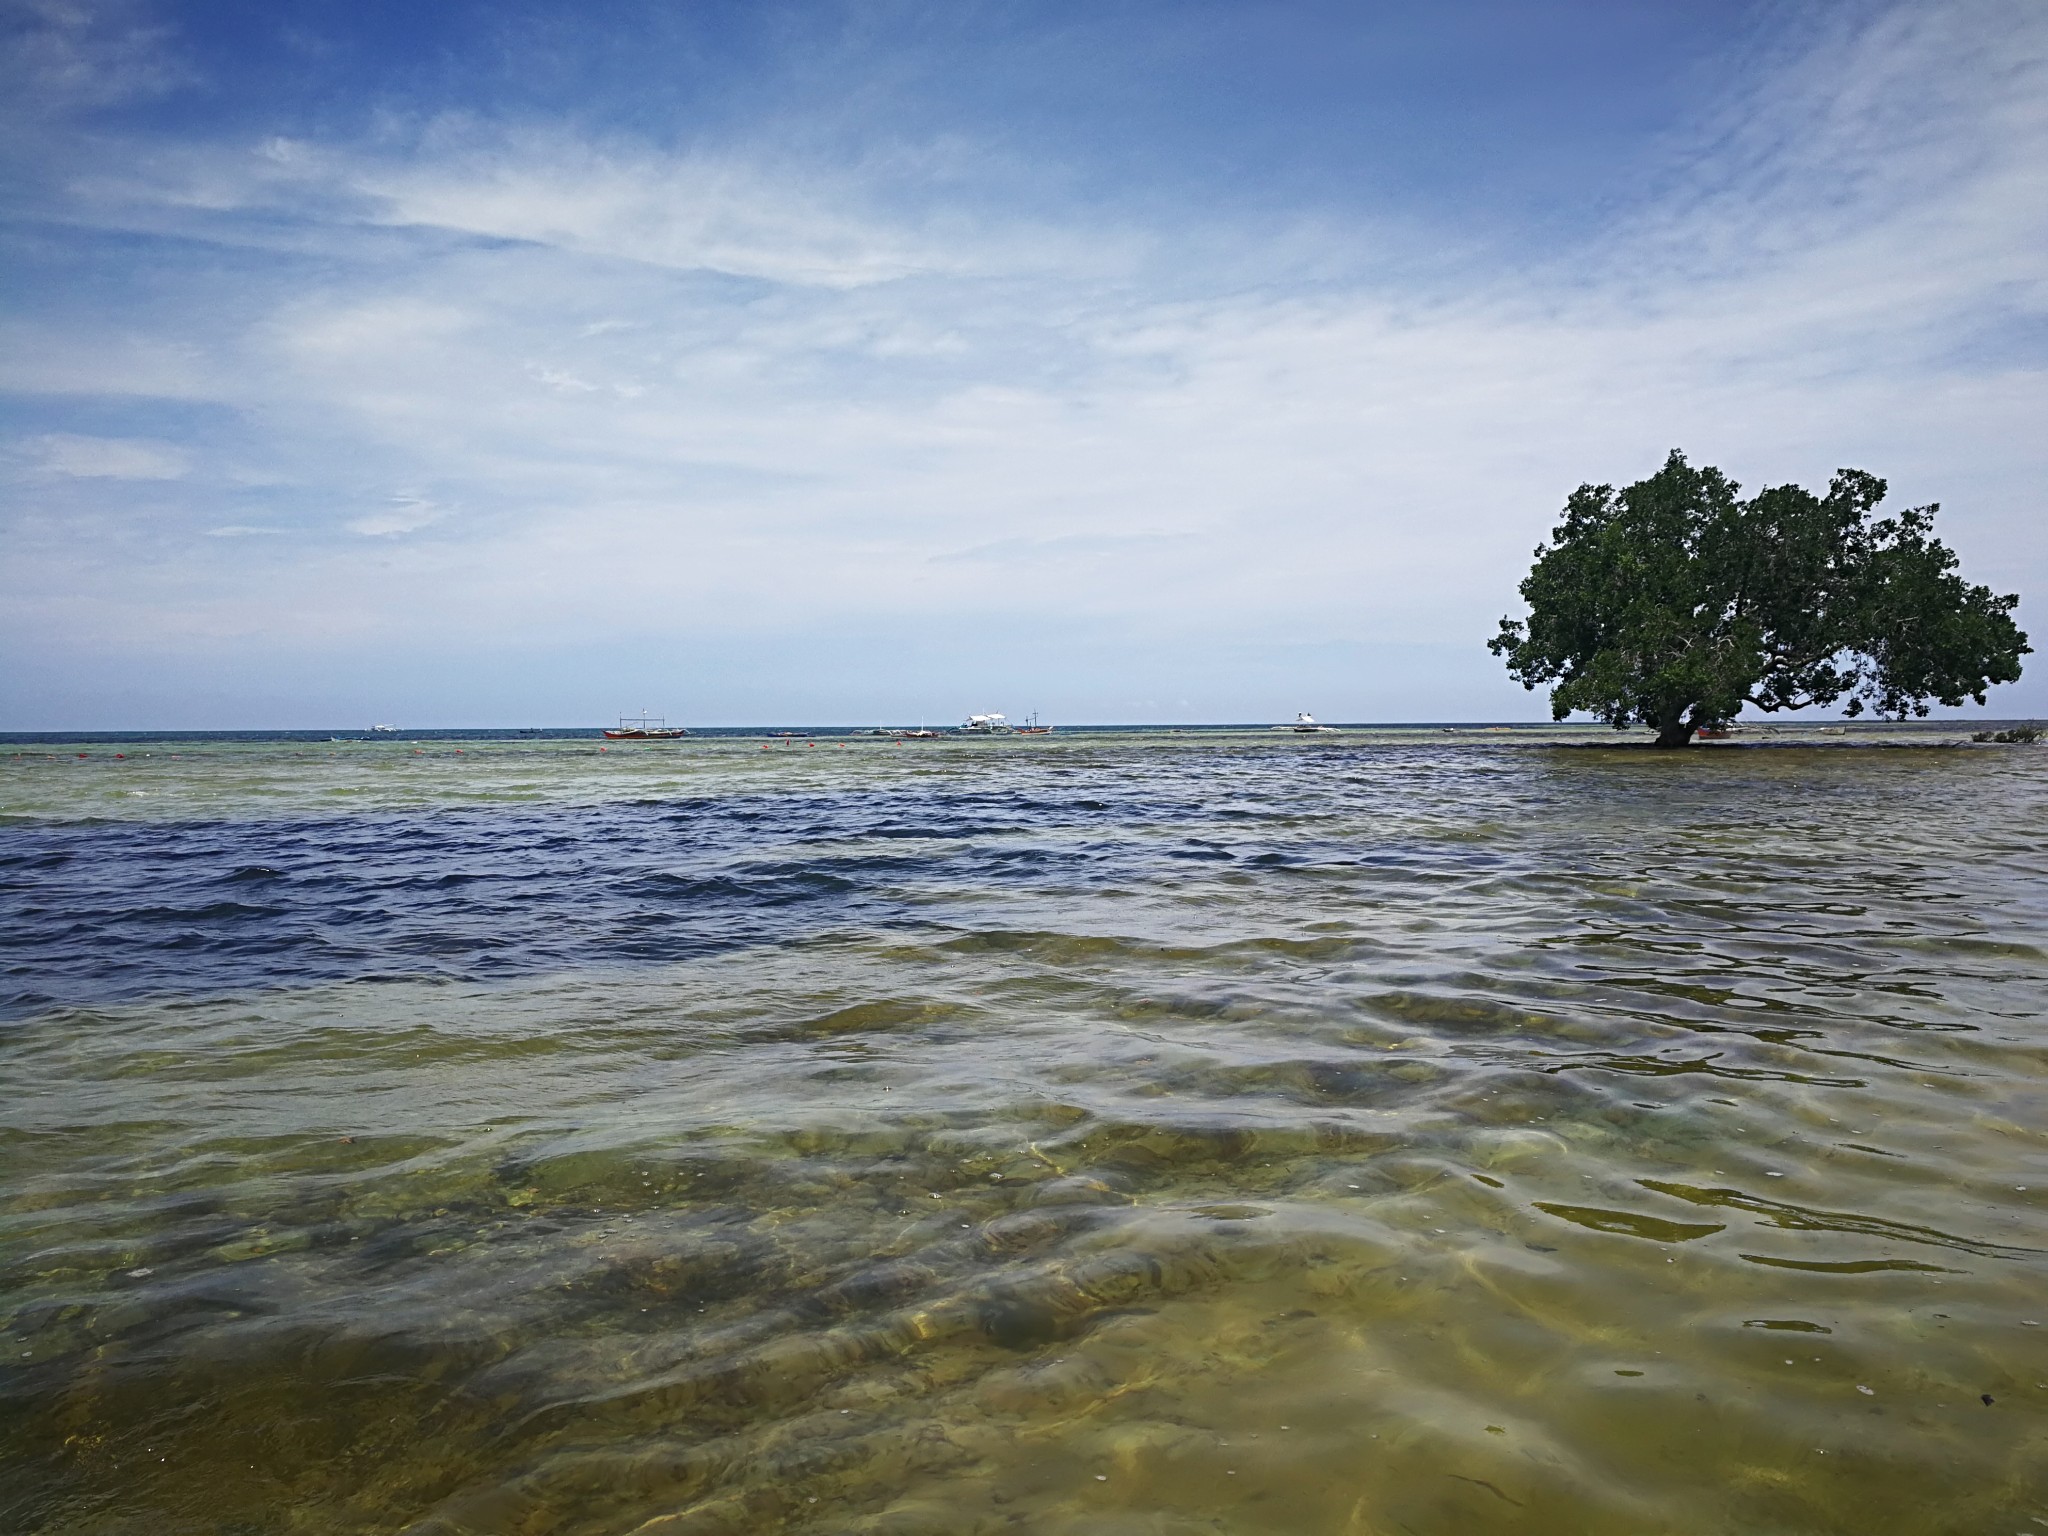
0 731 2048 1536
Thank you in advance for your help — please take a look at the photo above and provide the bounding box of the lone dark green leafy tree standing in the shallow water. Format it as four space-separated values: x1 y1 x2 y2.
1487 449 2034 748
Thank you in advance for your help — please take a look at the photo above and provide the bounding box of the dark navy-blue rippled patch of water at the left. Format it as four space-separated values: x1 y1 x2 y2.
0 791 1073 1014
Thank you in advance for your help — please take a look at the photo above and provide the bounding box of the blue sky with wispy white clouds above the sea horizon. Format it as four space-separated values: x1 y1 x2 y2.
0 0 2048 729
